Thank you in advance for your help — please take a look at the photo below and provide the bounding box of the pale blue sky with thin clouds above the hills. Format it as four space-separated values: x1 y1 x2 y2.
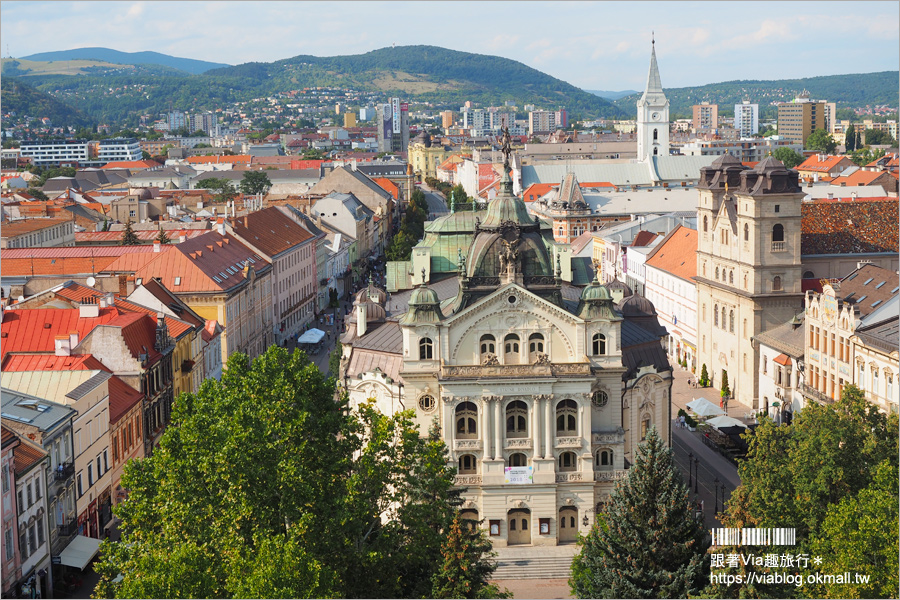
0 0 900 91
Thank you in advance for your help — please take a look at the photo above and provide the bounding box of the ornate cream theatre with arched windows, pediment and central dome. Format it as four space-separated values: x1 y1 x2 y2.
342 159 672 546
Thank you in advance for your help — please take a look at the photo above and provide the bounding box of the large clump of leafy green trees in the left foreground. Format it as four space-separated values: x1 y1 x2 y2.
94 346 503 598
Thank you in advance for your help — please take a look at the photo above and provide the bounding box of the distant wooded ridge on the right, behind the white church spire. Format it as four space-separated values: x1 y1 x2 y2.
614 71 900 118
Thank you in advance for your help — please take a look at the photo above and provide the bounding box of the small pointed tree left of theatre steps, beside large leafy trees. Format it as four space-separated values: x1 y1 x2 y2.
430 512 512 598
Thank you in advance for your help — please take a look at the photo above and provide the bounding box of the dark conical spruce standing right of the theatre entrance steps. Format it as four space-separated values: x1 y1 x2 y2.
569 428 709 598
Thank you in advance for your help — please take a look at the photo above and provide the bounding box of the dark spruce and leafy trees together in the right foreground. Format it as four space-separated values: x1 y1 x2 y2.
570 386 900 598
